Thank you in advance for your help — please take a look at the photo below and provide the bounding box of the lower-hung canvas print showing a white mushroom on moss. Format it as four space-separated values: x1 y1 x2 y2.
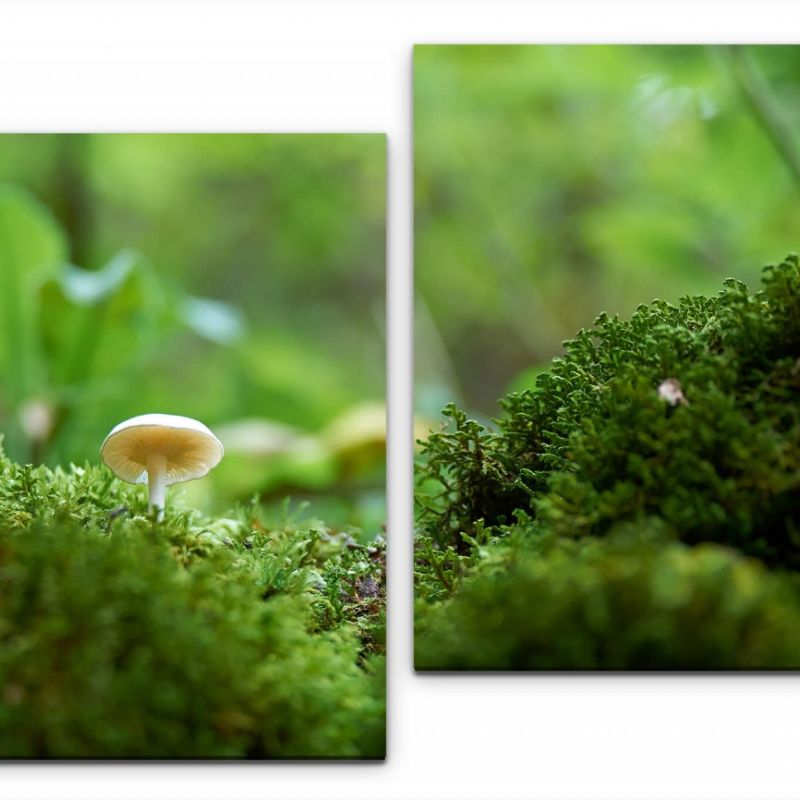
0 134 386 759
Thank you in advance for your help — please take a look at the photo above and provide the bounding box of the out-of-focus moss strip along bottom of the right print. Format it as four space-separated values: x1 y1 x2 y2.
416 526 800 670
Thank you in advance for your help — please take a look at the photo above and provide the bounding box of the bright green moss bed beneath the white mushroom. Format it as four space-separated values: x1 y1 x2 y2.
0 450 385 758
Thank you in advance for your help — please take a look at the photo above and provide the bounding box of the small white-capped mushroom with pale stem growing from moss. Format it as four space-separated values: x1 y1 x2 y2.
100 414 224 521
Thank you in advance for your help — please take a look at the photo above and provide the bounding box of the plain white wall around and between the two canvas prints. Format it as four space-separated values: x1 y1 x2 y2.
0 0 800 800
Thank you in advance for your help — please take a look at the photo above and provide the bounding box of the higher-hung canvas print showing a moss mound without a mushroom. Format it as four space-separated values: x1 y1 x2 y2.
414 45 800 671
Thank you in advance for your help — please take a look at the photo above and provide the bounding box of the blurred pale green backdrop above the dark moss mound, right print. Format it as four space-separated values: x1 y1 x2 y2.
414 45 800 419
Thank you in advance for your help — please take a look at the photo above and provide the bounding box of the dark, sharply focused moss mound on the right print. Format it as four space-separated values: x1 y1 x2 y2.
422 256 800 564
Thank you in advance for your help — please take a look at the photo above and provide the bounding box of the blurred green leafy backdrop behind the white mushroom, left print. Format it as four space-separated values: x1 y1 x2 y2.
0 134 386 535
